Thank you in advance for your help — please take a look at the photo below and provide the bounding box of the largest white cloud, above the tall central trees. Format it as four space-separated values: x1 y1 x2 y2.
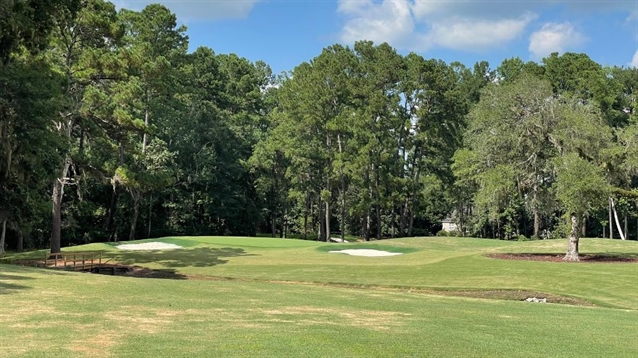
338 0 535 51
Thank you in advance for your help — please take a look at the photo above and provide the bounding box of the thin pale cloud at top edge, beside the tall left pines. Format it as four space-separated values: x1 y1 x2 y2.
114 0 261 22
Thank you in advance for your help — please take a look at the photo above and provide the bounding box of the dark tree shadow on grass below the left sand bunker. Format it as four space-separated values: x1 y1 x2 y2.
112 247 255 268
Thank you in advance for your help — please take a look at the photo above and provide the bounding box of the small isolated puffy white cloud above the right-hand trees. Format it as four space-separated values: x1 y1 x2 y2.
528 22 586 59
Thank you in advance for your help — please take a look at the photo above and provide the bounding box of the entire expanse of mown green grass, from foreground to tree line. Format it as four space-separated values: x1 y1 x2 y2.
0 237 638 357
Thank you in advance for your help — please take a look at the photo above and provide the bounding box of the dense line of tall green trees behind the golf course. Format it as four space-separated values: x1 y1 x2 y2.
0 0 638 257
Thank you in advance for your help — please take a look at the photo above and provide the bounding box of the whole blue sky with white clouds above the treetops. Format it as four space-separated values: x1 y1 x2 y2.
114 0 638 73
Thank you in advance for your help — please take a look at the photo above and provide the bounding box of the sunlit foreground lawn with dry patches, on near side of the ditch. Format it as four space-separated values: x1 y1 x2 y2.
0 264 638 357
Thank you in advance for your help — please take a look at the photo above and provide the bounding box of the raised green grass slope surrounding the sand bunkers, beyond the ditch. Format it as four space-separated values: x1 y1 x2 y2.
65 237 638 309
